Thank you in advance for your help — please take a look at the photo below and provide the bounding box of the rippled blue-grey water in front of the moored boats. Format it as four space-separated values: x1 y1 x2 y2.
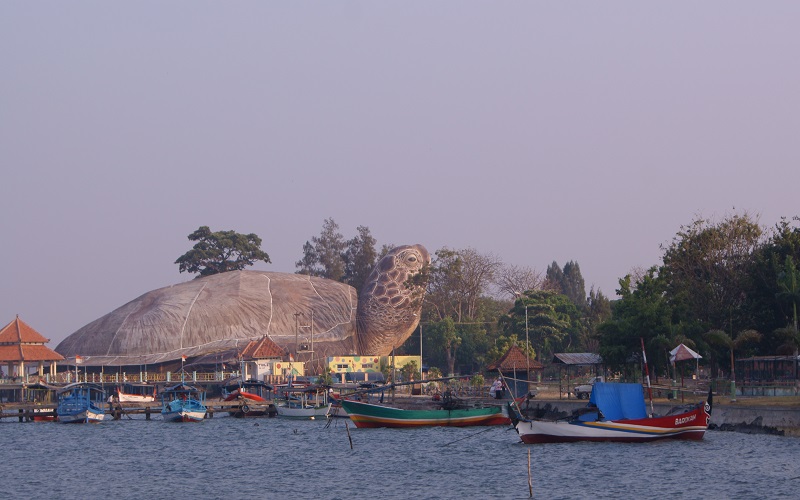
0 416 800 499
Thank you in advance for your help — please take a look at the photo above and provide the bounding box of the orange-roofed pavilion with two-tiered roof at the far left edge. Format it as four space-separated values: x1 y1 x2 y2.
0 316 64 380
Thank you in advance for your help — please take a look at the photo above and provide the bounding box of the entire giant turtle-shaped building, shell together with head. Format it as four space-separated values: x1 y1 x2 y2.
56 245 430 365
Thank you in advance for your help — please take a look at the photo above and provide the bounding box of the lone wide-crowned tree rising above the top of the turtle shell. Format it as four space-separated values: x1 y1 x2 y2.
175 226 270 277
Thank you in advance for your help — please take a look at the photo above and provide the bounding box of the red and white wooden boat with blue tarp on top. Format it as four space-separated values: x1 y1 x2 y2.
510 382 713 443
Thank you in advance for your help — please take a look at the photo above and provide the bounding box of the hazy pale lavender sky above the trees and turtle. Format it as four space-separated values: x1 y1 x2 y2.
0 0 800 347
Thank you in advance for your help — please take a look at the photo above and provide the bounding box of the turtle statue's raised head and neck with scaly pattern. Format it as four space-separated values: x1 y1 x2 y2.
356 245 431 356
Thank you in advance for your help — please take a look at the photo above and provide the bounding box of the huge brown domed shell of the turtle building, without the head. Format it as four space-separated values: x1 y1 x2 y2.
56 271 358 365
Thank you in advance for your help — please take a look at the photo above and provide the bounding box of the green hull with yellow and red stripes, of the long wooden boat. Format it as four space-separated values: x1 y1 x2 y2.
342 400 511 428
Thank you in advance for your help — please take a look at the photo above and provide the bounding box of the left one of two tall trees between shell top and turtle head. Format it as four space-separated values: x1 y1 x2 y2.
295 218 346 281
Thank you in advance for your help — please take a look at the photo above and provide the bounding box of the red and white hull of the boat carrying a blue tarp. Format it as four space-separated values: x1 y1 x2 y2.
514 405 710 444
